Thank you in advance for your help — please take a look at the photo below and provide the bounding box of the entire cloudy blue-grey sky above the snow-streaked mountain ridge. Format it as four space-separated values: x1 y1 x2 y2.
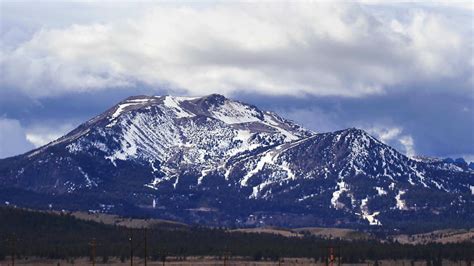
0 0 474 161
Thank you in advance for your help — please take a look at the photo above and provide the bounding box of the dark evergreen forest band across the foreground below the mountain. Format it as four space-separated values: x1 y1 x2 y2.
0 207 474 265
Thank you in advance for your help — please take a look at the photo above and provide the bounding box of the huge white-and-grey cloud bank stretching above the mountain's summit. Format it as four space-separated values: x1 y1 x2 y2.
0 2 474 98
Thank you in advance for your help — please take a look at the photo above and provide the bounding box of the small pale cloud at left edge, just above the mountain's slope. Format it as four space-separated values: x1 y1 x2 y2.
0 118 34 158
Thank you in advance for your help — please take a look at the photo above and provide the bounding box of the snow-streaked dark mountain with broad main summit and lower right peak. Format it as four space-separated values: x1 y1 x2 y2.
0 94 474 228
